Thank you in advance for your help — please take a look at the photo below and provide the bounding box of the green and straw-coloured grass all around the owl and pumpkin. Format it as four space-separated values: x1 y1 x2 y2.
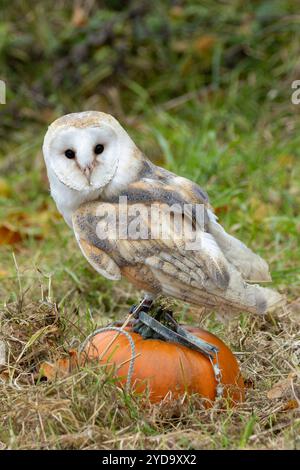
0 2 300 449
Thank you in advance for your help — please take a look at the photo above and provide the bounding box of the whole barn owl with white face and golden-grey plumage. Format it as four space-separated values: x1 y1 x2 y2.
43 111 281 314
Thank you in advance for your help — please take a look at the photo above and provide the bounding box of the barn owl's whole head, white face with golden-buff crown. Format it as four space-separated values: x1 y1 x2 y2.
43 111 135 193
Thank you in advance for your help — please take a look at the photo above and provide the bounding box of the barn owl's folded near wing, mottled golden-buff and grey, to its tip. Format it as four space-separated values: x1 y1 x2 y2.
73 202 279 313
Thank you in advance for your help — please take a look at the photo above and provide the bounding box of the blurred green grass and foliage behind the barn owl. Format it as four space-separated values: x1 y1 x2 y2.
0 0 300 302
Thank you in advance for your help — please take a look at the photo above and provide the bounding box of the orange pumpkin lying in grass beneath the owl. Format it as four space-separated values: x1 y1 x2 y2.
84 327 244 403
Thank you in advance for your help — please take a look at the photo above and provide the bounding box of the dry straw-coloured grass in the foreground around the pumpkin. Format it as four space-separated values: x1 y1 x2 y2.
0 284 300 449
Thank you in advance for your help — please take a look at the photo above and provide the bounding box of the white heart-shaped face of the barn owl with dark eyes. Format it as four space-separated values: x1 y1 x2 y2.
44 123 120 192
